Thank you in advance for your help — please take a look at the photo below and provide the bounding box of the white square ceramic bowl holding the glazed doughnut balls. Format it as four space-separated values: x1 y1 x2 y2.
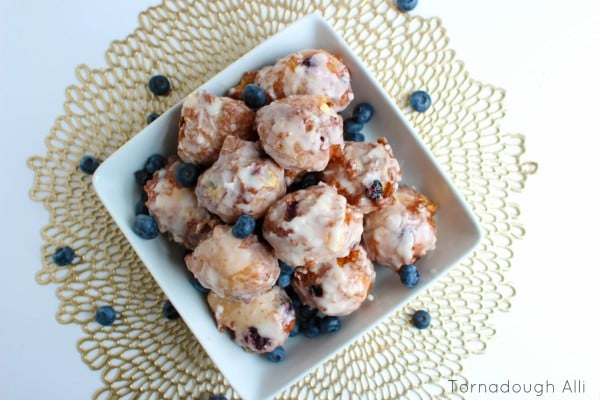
94 15 481 400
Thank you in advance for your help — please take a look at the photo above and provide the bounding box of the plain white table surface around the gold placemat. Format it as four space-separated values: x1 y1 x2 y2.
0 0 600 400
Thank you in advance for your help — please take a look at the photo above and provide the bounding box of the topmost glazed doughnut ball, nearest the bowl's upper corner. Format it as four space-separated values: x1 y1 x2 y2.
255 50 354 111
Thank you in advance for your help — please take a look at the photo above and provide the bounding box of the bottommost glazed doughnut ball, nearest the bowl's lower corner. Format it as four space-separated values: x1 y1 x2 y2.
208 286 296 353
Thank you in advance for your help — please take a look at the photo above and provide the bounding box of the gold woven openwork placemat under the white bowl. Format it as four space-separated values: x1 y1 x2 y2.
29 0 536 399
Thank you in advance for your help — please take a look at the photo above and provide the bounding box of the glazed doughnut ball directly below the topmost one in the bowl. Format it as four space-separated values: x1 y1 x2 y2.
256 96 344 171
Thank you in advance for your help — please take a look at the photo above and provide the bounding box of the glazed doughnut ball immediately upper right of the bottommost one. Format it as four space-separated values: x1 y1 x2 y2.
292 246 375 315
